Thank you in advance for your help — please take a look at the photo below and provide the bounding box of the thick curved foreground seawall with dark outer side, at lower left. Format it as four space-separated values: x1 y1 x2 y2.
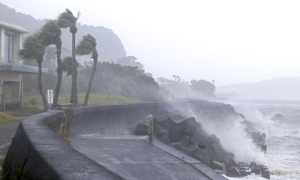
3 111 123 180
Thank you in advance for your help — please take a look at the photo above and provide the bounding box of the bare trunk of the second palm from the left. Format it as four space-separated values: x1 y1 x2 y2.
52 38 63 108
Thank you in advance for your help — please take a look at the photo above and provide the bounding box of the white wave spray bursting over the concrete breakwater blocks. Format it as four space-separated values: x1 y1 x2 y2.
188 104 268 165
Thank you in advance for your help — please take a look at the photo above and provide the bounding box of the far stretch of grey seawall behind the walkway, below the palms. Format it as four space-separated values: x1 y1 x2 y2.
69 101 189 135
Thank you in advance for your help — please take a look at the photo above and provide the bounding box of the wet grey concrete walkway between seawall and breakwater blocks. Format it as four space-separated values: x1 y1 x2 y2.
71 135 225 180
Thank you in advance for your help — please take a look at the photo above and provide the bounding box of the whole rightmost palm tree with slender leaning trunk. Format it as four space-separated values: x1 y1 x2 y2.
76 34 98 106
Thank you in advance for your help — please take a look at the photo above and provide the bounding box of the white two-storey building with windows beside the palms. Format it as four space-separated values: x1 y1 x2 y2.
0 21 48 107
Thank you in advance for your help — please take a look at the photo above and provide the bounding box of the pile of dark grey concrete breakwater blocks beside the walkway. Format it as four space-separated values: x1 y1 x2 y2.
137 111 240 177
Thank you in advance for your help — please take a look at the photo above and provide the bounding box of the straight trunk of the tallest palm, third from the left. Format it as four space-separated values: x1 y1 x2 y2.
70 33 78 103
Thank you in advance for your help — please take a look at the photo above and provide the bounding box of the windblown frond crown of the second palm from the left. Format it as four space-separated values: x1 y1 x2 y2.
40 20 61 46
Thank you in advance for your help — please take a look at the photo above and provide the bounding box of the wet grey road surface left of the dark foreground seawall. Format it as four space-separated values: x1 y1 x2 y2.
0 120 21 176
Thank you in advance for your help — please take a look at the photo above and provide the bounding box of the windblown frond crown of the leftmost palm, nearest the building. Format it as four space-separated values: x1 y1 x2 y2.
18 33 45 60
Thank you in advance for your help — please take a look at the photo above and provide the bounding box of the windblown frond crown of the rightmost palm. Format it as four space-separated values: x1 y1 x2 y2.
76 34 97 55
